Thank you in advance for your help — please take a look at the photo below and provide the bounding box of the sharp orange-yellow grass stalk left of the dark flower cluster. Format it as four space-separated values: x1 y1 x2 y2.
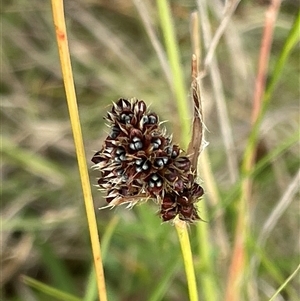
52 0 107 301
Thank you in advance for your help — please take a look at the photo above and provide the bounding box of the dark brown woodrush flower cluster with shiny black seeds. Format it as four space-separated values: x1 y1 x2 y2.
92 99 203 222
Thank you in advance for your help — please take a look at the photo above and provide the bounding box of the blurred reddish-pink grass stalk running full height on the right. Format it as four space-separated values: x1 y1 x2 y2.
225 0 281 301
